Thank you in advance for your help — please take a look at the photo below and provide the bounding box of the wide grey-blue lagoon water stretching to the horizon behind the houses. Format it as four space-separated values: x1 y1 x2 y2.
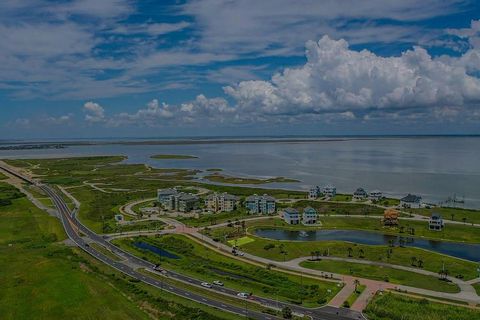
0 137 480 208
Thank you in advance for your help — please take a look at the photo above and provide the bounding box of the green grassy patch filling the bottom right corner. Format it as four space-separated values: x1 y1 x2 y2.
364 293 480 320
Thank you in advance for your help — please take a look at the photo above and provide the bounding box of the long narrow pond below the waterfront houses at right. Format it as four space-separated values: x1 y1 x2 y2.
254 229 480 262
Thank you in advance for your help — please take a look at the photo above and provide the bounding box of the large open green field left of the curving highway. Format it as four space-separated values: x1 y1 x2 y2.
0 179 246 320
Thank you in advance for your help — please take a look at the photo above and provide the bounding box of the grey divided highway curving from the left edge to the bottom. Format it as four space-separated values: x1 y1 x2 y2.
0 166 363 320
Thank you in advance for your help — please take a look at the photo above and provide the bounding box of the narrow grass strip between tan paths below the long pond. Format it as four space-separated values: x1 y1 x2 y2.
300 260 460 293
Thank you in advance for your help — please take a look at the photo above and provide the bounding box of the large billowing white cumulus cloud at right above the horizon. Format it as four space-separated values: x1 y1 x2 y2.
224 36 480 119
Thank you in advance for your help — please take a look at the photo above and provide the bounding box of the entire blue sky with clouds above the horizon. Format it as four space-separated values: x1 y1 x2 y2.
0 0 480 139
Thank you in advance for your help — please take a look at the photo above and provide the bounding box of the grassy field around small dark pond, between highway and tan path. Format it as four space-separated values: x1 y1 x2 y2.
114 235 339 306
